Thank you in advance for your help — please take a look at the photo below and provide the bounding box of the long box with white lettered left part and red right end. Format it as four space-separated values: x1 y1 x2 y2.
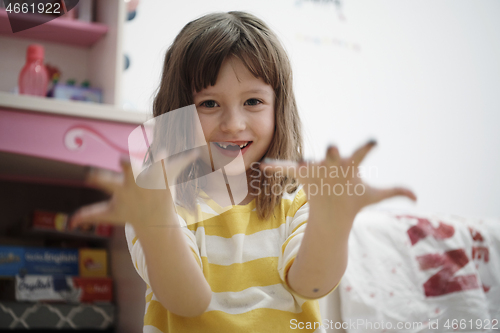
15 275 113 303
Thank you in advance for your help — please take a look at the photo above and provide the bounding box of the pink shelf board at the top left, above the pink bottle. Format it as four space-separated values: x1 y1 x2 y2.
0 9 108 47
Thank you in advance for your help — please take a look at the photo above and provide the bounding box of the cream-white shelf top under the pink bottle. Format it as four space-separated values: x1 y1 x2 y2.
0 92 149 124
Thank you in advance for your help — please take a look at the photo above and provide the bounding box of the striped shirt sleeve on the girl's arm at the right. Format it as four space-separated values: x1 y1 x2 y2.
278 188 340 300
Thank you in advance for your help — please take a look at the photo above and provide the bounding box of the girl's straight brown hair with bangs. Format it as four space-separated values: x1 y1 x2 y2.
153 11 302 219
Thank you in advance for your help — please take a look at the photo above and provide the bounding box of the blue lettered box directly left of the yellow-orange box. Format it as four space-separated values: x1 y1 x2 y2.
24 248 78 276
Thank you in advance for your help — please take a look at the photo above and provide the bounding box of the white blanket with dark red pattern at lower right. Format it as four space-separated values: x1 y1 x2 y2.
339 210 500 332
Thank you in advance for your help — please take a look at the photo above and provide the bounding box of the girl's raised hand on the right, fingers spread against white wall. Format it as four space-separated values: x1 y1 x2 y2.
261 140 417 220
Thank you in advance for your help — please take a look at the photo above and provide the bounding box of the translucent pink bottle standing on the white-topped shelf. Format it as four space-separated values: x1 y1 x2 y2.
19 44 49 96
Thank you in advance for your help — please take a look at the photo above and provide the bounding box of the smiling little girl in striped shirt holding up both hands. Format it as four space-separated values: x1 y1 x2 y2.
72 12 416 333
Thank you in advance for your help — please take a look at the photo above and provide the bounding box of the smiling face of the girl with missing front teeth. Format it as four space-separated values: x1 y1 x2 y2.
193 57 274 174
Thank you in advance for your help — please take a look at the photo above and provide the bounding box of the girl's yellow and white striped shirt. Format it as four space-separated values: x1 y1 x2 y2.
125 187 335 333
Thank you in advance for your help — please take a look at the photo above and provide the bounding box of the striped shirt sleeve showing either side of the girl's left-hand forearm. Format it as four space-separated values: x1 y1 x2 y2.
125 215 203 286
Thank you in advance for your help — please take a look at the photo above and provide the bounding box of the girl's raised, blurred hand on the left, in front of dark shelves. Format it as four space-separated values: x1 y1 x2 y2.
70 150 198 229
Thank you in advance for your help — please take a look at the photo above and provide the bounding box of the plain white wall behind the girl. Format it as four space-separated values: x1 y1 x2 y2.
123 0 500 217
